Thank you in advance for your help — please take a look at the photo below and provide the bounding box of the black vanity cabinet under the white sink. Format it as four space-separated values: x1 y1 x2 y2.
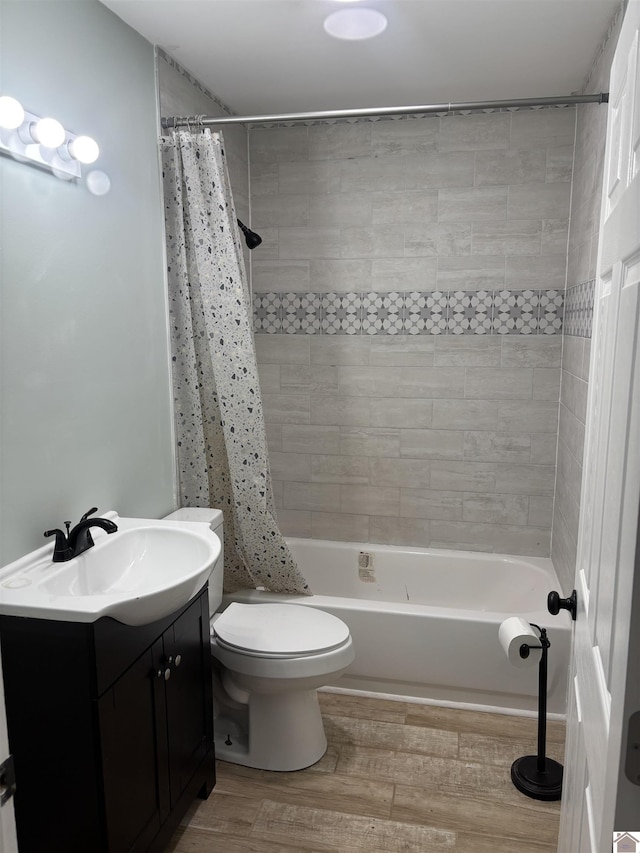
0 586 215 853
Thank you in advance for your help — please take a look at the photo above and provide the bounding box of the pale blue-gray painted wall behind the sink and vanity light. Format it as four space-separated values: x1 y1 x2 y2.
0 0 174 564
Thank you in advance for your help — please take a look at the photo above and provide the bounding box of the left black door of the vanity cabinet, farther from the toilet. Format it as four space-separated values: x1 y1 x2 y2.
98 640 166 853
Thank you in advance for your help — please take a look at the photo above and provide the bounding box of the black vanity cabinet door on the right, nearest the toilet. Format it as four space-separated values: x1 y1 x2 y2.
163 590 213 808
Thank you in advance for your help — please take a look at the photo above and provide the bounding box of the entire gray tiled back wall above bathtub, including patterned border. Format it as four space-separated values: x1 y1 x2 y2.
250 109 575 555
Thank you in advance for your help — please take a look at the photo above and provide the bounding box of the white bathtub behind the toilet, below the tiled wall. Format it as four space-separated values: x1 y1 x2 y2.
222 538 571 718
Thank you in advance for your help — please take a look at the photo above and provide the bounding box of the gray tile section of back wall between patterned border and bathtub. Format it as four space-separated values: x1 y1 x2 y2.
256 335 561 555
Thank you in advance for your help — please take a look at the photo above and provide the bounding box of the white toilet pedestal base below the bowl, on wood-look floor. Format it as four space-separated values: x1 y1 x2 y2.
214 689 327 771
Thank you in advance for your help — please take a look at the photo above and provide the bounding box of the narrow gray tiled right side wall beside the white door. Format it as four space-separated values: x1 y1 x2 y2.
551 6 622 593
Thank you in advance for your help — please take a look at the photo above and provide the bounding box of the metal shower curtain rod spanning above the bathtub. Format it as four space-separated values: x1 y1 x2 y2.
161 92 609 130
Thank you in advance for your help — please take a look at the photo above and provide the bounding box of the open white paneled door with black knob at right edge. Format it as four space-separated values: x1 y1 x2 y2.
558 0 640 853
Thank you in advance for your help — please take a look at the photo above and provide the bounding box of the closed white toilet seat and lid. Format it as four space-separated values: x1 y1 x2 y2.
212 602 350 659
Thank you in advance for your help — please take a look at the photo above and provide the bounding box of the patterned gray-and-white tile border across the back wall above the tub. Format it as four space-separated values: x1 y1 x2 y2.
253 290 564 335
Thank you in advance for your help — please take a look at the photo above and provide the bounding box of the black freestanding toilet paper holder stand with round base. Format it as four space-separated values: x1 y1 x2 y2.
511 622 563 801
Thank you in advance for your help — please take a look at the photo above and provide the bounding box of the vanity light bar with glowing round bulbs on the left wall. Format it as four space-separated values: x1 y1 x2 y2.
0 95 100 180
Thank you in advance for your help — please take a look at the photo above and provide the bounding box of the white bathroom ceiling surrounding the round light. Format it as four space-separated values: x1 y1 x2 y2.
102 0 620 115
